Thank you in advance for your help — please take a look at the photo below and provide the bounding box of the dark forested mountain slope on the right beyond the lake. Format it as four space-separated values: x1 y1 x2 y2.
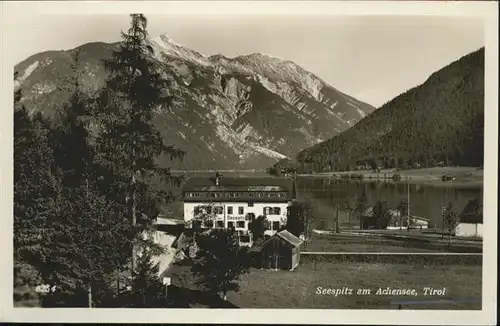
297 48 484 171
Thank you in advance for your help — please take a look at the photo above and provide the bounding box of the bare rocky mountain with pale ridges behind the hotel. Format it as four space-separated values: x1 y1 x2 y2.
15 35 375 169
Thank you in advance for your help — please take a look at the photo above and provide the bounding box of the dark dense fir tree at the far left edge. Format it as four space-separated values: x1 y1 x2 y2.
14 107 62 306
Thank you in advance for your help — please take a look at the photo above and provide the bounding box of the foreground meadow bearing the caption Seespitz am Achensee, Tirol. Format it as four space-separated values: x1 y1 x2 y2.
169 262 482 310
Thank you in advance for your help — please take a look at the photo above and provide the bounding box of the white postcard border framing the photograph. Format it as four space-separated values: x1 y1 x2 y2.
0 1 498 325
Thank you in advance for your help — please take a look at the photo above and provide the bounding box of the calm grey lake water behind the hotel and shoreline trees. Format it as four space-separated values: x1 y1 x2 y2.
169 172 483 230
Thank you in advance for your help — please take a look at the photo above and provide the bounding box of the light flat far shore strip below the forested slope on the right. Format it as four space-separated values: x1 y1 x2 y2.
298 167 484 187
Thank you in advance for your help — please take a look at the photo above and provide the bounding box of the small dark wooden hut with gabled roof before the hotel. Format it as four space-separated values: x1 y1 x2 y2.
253 230 302 271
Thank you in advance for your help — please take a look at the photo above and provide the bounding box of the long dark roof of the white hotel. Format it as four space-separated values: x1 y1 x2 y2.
182 176 295 200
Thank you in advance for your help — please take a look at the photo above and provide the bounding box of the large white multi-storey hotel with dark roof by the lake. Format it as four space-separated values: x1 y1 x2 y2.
183 174 295 235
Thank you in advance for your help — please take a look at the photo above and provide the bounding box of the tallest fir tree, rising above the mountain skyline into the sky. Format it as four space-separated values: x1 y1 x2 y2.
97 14 183 286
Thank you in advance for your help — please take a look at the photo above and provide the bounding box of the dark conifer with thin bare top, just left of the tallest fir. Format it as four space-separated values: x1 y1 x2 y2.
45 53 132 307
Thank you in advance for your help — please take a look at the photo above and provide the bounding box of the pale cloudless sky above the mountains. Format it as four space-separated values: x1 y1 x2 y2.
9 14 485 107
